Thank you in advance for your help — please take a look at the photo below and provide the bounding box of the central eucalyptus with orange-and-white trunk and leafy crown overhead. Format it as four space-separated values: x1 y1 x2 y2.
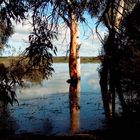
26 0 104 80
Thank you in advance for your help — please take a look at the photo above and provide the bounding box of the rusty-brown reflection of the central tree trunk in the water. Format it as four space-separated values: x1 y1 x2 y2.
69 80 80 133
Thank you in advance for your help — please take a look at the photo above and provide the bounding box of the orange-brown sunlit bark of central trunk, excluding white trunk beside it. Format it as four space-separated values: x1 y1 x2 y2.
69 12 78 80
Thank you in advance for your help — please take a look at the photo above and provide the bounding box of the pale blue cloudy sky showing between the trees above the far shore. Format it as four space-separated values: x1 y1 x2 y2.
2 17 105 57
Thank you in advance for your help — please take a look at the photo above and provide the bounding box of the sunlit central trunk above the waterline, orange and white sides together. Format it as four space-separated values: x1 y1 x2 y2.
66 0 81 82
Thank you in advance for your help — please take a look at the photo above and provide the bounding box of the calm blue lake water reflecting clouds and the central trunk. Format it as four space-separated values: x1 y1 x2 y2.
0 63 105 135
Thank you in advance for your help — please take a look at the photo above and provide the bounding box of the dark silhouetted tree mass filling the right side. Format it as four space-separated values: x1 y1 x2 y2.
97 0 139 116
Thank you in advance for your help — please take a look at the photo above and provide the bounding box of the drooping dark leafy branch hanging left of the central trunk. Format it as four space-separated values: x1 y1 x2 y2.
24 17 57 78
